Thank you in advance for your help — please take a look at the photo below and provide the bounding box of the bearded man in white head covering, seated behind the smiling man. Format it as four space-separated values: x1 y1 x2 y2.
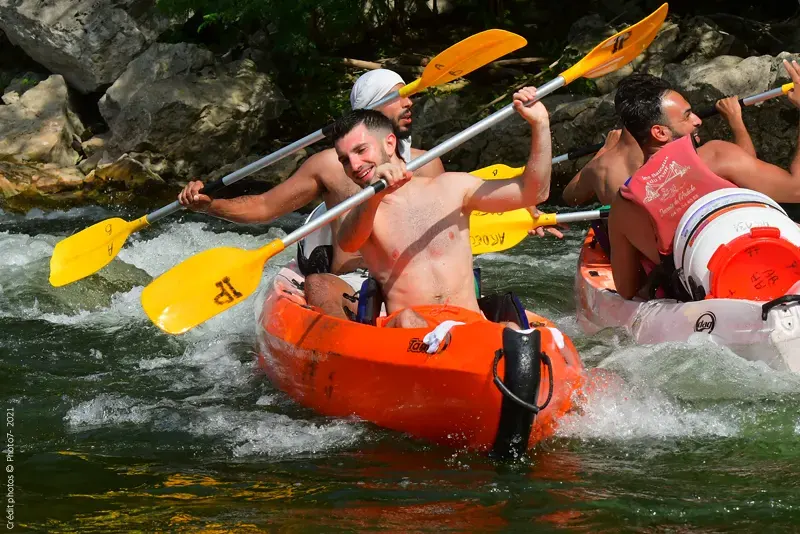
178 69 444 318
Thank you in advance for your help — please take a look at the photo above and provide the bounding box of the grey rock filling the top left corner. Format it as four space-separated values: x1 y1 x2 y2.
0 0 177 93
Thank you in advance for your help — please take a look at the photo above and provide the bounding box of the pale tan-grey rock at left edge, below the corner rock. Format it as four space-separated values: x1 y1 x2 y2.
0 75 83 166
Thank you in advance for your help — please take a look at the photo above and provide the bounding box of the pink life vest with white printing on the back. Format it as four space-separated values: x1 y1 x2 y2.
620 135 737 256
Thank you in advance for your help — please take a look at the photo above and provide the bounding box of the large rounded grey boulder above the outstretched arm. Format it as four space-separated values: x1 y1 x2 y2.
100 44 288 179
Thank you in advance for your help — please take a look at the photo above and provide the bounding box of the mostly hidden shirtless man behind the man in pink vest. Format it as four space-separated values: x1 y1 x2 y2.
563 74 756 206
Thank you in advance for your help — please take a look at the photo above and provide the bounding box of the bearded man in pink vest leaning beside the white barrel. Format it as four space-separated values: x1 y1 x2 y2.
608 61 800 299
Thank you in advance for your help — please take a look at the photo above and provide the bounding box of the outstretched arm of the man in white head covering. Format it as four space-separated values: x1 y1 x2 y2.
178 151 330 223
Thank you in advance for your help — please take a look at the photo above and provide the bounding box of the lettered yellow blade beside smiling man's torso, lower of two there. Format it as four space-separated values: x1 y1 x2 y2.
469 209 534 254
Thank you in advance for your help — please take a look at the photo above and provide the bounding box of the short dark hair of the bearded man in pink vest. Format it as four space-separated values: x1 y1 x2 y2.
614 74 673 145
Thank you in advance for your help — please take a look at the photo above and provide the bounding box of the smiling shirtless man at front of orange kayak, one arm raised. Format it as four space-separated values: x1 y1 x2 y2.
333 88 552 328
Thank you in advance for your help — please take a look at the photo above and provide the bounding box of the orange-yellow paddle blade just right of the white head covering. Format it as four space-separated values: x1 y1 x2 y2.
400 29 528 97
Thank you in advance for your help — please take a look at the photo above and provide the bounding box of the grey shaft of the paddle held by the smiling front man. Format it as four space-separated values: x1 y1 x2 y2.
281 76 566 248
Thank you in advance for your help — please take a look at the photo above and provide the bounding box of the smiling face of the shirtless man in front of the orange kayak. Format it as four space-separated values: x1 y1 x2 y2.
334 123 397 187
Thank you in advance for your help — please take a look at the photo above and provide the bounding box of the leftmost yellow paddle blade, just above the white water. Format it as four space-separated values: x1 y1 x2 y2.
50 217 147 287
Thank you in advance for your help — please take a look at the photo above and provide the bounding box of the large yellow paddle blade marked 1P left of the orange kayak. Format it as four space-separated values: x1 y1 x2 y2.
142 239 284 334
